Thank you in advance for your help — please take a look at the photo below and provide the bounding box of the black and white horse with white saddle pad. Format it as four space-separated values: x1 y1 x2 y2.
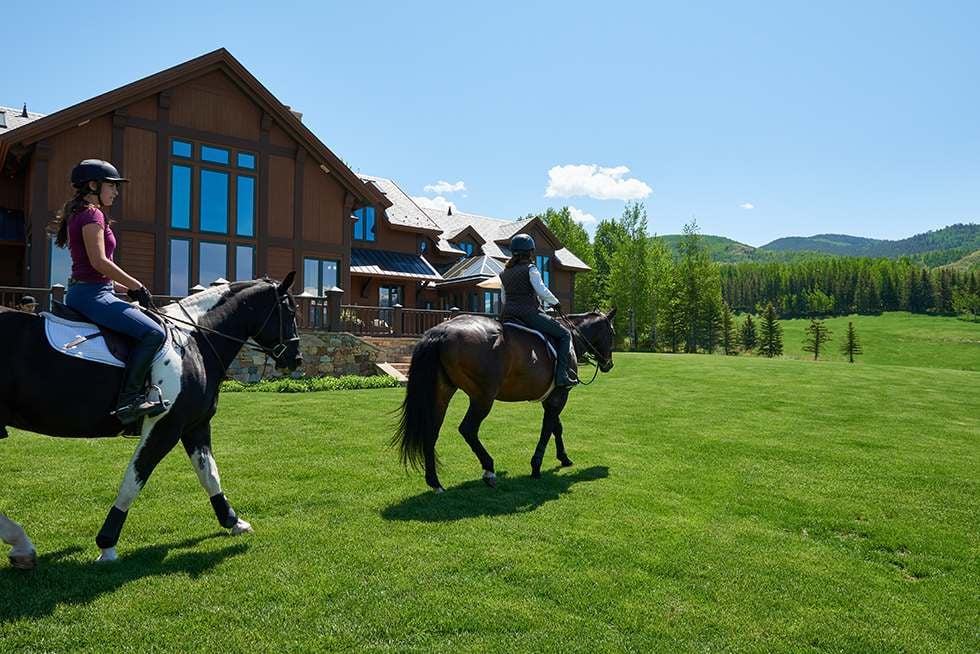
0 273 302 568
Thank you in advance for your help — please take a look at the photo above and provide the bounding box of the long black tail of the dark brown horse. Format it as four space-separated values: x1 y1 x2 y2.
391 327 444 469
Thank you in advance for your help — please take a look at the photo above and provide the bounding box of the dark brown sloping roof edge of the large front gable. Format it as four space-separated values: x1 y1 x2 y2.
0 48 390 207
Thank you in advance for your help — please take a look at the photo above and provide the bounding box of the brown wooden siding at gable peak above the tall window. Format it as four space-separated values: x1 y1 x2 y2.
170 71 262 141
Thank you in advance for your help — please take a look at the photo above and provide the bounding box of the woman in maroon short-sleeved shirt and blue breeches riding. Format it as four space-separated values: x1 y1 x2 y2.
55 159 166 425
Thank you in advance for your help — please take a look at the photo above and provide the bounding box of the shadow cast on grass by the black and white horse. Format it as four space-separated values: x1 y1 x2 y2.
0 532 247 623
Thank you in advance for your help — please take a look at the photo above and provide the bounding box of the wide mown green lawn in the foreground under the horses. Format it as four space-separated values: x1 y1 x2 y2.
0 348 980 653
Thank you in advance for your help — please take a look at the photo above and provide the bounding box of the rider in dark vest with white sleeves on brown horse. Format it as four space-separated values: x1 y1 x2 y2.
500 234 578 386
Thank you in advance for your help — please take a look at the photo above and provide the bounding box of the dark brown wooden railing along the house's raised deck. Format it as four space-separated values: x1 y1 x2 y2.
0 284 489 336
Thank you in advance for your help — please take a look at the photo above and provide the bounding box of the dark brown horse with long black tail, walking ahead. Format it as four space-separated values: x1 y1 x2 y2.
392 309 616 493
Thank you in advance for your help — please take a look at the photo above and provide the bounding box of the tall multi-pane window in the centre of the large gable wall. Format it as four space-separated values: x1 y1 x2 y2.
170 139 258 295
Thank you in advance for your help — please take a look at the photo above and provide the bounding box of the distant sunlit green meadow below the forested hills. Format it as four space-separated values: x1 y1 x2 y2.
768 311 980 371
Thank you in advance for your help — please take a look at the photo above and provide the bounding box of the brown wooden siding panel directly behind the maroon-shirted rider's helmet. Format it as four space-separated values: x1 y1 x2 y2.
45 115 112 211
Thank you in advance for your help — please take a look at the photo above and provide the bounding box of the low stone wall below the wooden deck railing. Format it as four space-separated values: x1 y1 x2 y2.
227 331 380 382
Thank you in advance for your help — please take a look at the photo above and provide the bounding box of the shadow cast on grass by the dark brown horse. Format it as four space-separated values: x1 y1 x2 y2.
381 466 609 522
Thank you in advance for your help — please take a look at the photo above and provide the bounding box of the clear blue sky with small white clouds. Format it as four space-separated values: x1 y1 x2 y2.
0 0 980 245
